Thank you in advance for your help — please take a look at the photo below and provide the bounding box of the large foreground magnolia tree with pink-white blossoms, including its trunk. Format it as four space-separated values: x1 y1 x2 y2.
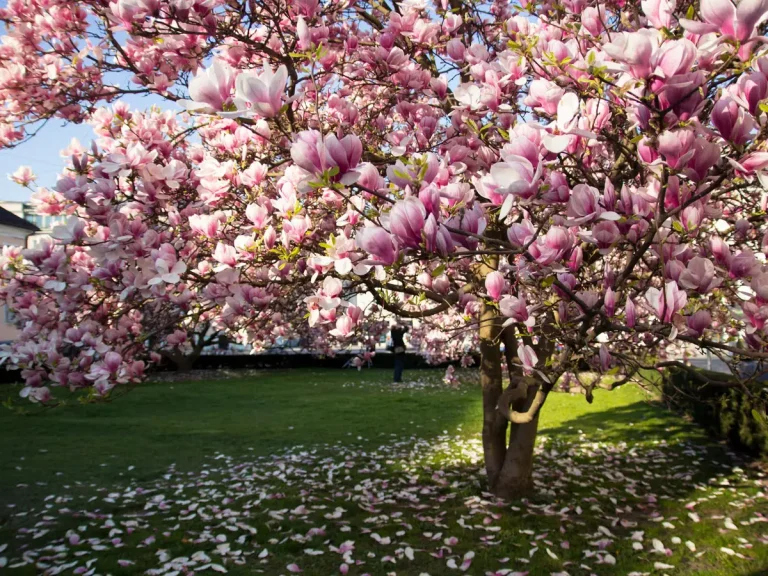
0 0 768 496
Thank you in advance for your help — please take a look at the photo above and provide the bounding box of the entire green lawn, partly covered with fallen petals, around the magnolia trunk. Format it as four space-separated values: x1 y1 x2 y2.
0 370 768 576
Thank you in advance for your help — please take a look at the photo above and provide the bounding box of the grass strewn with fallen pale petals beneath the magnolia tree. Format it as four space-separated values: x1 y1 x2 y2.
0 403 768 576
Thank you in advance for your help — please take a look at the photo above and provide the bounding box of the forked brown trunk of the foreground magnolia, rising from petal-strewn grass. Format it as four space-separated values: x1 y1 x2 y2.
480 305 539 499
